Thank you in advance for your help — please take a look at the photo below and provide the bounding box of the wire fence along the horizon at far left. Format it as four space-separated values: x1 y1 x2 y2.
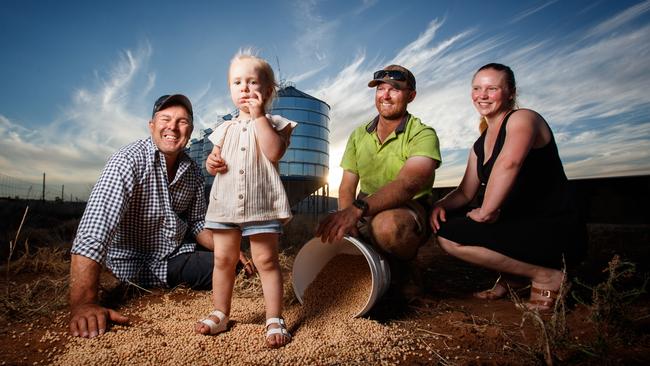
0 173 80 202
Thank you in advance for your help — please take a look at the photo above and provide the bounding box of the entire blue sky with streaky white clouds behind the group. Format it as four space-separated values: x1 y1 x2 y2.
0 0 650 198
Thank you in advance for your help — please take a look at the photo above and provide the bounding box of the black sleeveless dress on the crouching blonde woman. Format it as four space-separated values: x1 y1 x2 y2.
438 111 587 268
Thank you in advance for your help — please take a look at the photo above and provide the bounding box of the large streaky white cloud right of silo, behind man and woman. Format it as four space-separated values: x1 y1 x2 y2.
309 2 650 190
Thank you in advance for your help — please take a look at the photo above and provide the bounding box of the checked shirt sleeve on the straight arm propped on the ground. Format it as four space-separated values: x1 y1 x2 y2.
71 153 137 263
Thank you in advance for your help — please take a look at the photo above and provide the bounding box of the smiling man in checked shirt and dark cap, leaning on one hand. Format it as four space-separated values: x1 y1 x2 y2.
70 94 254 338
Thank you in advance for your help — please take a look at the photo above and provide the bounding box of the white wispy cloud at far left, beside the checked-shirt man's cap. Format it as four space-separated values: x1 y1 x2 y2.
0 44 155 195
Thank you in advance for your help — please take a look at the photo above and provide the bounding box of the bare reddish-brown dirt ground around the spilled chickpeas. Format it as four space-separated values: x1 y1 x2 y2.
0 230 650 365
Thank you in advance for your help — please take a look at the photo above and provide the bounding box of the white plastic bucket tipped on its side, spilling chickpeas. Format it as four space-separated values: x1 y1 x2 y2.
292 236 390 317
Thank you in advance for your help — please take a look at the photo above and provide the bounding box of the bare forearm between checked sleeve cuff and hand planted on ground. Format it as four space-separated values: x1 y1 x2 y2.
70 254 101 307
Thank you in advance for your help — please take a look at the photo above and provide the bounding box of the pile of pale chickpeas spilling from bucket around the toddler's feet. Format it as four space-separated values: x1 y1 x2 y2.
53 255 426 365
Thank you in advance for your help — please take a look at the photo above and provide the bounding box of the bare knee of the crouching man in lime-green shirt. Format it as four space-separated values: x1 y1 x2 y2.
371 209 420 260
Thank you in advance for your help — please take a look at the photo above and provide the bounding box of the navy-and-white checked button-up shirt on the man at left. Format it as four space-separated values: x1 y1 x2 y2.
71 138 206 287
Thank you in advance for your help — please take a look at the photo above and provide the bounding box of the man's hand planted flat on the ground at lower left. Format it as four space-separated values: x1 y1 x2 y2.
70 304 129 338
